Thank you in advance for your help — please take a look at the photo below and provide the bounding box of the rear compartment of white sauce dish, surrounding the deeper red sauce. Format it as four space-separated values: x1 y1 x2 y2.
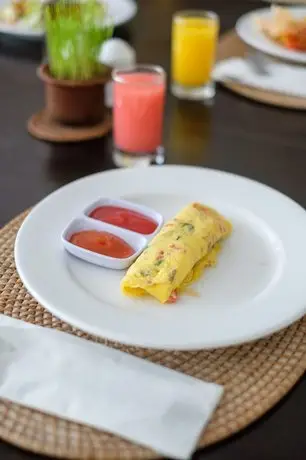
84 198 164 240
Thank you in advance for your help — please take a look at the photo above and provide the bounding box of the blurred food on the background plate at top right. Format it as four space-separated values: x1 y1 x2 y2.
256 6 306 52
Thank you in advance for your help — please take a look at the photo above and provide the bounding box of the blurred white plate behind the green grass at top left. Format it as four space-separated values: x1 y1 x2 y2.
0 0 137 40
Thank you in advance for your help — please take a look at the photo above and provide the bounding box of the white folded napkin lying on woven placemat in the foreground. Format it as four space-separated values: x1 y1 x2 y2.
0 315 222 459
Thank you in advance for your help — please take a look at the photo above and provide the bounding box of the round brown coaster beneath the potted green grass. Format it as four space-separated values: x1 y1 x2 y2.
28 110 112 142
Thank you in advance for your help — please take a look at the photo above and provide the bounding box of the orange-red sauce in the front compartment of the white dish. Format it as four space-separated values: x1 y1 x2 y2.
69 230 135 259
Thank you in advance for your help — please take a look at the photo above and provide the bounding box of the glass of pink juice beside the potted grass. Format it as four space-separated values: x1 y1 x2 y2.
113 65 166 165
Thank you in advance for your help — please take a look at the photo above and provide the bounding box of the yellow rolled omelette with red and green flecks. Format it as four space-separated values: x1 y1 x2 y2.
121 203 232 303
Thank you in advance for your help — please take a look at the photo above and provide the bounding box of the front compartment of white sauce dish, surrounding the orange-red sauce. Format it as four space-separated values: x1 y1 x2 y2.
62 216 148 270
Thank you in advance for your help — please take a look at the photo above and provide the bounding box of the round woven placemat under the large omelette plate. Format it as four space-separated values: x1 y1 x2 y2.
0 213 306 460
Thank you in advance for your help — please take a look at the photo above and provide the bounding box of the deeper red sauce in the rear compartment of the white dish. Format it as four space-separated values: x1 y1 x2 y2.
89 206 157 235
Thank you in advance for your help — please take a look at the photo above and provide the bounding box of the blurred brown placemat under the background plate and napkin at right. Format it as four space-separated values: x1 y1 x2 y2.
218 31 306 110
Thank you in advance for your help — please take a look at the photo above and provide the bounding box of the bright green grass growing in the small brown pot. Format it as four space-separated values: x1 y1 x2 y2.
44 0 113 80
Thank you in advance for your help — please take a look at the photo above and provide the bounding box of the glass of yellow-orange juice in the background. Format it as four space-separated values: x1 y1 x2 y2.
171 10 219 100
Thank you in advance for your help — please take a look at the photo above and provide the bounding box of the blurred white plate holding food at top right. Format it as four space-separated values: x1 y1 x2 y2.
236 7 306 64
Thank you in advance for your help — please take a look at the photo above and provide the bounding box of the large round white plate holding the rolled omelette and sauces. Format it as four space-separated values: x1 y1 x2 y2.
15 166 306 350
